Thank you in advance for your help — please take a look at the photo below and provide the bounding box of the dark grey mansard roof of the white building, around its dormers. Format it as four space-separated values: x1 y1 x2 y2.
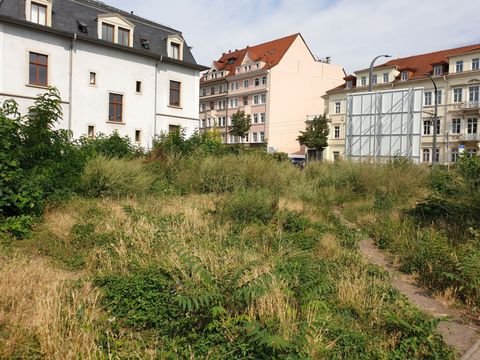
0 0 197 64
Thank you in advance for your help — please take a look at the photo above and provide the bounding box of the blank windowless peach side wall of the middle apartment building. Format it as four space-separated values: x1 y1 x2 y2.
266 36 345 154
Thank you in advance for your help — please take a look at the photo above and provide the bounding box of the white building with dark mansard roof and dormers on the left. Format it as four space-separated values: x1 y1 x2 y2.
0 0 207 147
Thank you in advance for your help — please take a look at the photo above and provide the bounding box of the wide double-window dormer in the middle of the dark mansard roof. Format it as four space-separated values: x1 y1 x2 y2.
98 14 134 46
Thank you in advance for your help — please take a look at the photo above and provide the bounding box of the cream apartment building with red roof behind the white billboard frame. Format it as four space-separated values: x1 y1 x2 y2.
324 44 480 164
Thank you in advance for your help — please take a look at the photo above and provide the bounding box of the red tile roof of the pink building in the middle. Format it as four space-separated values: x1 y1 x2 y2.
201 33 300 81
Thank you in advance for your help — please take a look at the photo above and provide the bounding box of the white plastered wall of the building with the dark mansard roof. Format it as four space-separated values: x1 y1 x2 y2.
0 24 200 148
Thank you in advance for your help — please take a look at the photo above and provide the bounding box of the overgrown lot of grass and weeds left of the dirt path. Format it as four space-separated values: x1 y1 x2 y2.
0 154 453 359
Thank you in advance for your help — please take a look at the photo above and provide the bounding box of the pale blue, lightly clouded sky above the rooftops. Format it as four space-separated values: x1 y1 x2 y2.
109 0 480 73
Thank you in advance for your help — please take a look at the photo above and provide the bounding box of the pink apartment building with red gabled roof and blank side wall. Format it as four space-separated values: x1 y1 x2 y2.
200 34 345 156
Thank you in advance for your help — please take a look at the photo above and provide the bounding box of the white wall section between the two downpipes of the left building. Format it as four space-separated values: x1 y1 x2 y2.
71 41 155 146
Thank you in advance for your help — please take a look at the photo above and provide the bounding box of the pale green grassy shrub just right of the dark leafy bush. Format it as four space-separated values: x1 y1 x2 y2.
81 156 155 197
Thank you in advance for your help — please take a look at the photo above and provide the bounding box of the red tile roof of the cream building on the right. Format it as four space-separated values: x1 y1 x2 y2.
327 44 480 93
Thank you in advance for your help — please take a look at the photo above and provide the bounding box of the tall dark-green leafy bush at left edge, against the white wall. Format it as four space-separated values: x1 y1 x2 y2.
0 88 85 217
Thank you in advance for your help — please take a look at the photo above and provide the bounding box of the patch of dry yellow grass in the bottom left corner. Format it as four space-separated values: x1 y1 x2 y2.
0 256 100 359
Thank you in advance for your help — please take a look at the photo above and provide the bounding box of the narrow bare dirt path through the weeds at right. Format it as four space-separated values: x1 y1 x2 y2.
335 211 480 360
